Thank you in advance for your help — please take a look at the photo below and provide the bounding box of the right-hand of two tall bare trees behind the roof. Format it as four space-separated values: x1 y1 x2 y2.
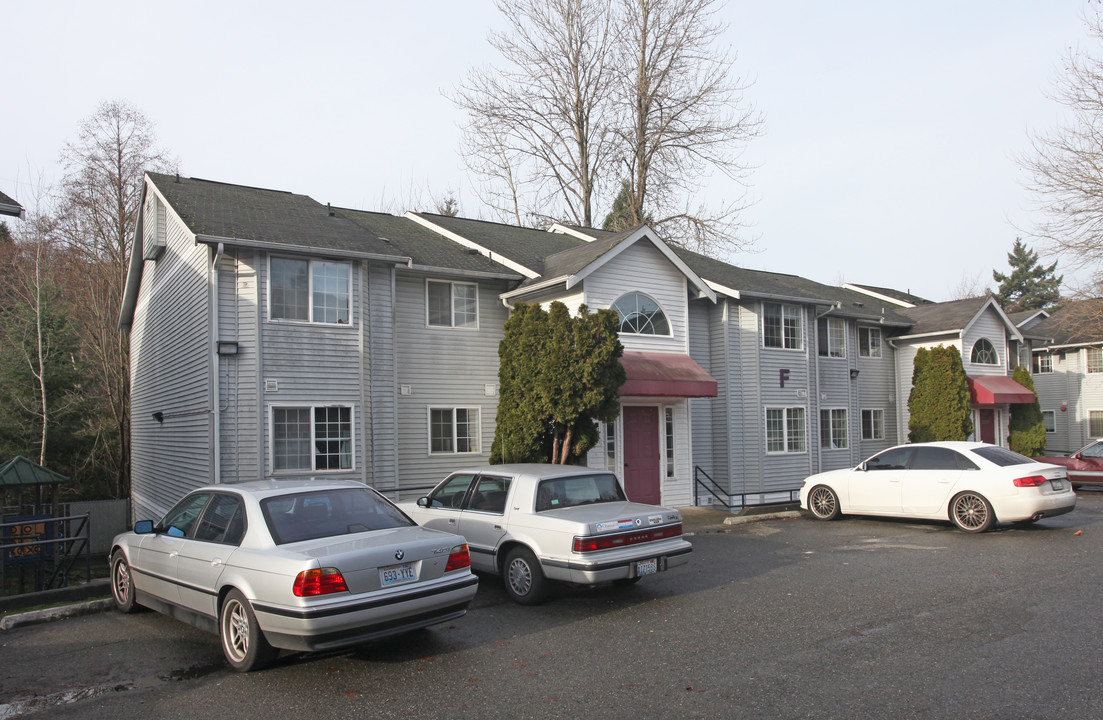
618 0 762 252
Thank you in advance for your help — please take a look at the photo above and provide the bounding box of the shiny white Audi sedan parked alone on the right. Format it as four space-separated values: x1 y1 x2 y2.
801 442 1077 533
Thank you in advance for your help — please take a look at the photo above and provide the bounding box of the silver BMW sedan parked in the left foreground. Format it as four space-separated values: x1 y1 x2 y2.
110 480 479 671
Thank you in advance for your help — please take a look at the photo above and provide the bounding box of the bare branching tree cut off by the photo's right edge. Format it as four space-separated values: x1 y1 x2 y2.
1020 10 1103 295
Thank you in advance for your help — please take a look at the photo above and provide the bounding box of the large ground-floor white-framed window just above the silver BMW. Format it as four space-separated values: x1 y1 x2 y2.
271 405 354 472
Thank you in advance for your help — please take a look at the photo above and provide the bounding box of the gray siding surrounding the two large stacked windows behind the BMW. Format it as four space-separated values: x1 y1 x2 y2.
258 255 366 482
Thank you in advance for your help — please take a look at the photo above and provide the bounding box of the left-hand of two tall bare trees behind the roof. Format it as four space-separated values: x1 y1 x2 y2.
453 0 613 226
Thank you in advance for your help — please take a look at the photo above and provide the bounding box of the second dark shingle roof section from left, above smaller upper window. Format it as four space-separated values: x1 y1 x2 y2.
338 208 522 280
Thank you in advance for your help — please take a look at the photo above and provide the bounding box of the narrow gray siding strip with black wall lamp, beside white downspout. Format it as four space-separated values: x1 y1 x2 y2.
215 248 264 483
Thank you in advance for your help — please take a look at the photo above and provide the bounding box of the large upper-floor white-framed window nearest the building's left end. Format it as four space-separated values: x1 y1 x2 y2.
268 257 352 325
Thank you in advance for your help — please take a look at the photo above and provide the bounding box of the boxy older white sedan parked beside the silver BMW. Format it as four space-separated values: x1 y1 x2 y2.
399 463 693 605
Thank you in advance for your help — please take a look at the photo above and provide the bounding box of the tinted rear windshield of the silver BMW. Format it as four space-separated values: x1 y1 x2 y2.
260 487 414 545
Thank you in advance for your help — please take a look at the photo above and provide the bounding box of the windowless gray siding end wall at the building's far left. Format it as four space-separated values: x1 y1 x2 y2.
130 205 214 519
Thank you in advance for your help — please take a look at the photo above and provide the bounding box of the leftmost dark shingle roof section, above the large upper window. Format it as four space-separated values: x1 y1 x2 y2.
149 173 398 256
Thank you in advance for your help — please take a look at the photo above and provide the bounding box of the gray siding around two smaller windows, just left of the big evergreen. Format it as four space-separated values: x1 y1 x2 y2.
395 273 508 498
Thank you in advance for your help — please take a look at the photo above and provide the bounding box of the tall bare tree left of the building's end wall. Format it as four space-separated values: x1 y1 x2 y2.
57 100 175 497
